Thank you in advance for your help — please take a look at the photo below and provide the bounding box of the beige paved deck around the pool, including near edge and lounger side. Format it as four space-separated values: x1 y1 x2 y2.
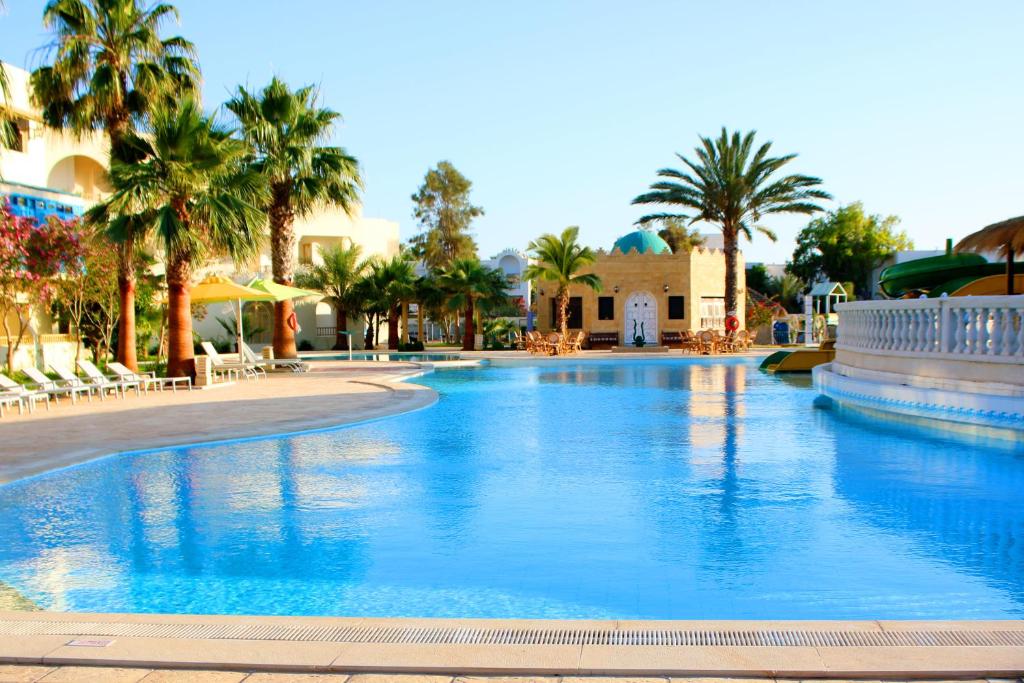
0 352 1024 683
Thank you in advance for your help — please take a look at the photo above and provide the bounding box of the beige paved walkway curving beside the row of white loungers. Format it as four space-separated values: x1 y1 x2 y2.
0 361 437 483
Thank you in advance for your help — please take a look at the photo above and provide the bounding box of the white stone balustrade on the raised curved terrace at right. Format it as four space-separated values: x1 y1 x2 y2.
836 296 1024 362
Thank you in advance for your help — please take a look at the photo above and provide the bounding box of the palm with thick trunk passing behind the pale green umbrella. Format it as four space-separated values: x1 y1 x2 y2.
226 78 362 358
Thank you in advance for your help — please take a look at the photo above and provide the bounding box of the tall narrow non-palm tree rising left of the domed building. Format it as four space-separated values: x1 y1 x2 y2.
412 161 483 270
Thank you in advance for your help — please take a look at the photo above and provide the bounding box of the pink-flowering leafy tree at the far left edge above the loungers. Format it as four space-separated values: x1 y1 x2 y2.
0 202 83 371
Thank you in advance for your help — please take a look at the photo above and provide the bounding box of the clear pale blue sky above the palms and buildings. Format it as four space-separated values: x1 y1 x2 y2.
0 0 1024 261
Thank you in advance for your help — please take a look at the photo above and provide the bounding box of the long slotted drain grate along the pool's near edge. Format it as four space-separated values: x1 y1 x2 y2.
0 621 1024 647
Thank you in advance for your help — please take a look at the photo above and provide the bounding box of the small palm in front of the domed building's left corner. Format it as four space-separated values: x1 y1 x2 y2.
522 225 601 337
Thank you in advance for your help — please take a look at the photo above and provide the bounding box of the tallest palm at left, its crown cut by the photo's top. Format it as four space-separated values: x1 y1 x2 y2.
32 0 200 370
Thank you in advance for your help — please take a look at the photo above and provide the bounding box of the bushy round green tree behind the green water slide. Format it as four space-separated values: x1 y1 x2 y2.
787 202 913 295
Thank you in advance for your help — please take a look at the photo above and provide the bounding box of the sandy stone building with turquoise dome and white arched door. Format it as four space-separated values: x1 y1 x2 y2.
537 230 746 348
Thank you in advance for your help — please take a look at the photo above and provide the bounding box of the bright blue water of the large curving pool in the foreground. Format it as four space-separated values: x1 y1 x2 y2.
0 359 1024 618
